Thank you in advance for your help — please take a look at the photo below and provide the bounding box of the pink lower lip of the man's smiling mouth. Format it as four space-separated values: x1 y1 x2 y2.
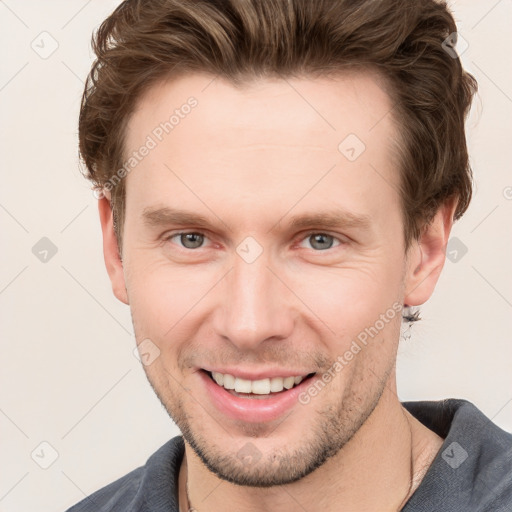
198 370 312 423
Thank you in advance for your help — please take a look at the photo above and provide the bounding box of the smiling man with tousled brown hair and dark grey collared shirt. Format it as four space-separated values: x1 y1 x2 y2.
66 0 512 512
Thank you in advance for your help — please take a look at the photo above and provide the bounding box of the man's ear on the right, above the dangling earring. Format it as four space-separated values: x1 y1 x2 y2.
404 197 458 306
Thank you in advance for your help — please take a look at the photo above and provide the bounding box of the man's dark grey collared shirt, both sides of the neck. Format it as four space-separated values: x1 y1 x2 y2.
67 399 512 512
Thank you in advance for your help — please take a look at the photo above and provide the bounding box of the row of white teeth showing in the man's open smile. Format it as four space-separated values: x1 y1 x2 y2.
202 370 316 399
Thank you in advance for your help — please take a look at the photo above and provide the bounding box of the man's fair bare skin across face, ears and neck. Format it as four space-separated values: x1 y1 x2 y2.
99 73 456 512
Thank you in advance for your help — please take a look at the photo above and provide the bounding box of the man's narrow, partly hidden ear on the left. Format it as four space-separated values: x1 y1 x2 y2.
98 197 128 304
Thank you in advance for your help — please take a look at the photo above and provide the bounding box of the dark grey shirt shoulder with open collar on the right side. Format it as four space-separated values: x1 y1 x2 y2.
403 399 512 512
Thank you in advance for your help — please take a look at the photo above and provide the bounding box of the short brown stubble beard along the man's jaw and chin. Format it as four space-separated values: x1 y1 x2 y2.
145 362 391 488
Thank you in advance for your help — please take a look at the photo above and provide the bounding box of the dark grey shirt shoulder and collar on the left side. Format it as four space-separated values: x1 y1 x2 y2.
66 436 184 512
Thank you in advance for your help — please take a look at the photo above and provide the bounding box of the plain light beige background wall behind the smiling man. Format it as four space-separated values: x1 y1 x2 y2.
0 0 512 512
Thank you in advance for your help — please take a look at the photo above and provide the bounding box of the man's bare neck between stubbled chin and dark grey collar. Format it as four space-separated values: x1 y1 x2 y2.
179 388 442 512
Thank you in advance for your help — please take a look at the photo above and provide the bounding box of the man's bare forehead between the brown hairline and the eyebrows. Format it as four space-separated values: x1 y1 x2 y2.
125 73 398 232
